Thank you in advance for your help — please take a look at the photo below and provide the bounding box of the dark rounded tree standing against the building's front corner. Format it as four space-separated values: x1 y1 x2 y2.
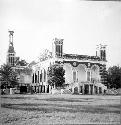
48 64 65 88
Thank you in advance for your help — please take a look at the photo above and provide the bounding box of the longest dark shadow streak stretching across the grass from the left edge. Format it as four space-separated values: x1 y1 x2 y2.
1 103 120 114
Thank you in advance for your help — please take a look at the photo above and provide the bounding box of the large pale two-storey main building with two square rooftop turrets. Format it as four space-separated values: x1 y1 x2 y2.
31 38 107 94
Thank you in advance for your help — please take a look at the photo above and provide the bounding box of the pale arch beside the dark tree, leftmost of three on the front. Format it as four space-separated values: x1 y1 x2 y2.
63 63 73 83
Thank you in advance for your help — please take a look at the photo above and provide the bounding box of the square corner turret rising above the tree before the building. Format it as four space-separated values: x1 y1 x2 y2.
52 38 63 58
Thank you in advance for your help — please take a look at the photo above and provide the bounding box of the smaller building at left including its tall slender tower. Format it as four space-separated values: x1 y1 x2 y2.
6 31 32 91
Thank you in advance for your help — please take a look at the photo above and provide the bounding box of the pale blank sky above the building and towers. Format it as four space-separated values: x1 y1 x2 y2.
0 0 121 66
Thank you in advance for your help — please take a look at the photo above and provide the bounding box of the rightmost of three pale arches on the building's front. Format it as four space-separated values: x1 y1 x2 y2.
91 65 100 81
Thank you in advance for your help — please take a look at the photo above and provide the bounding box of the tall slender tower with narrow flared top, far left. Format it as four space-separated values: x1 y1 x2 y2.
6 31 15 66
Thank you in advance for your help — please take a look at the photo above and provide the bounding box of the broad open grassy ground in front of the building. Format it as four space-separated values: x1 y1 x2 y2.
0 94 120 125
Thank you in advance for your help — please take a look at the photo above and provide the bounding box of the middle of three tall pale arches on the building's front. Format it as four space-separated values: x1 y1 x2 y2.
77 64 87 82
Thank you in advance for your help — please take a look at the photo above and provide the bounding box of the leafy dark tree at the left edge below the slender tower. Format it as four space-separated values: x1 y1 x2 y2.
0 64 18 87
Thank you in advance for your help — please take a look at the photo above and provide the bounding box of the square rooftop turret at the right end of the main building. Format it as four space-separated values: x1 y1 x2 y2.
96 44 106 61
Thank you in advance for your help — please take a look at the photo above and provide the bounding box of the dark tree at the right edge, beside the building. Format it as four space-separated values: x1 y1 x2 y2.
107 66 121 89
